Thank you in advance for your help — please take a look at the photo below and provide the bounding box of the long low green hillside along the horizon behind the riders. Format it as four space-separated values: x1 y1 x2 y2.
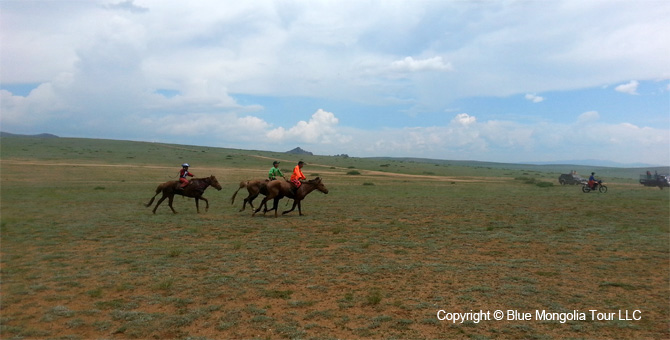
0 133 670 184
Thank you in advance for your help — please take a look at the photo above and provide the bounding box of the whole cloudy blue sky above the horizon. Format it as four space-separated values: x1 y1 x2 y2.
0 0 670 165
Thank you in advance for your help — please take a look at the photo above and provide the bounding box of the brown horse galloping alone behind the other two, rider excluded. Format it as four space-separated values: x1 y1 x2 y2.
145 175 221 214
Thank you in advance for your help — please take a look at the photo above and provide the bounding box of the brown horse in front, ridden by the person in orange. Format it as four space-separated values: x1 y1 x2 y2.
252 177 328 217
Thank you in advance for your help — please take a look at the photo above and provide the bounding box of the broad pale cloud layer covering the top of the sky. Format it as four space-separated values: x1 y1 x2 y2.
0 0 670 100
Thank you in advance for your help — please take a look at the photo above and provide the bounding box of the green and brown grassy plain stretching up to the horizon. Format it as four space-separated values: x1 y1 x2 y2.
0 138 670 339
